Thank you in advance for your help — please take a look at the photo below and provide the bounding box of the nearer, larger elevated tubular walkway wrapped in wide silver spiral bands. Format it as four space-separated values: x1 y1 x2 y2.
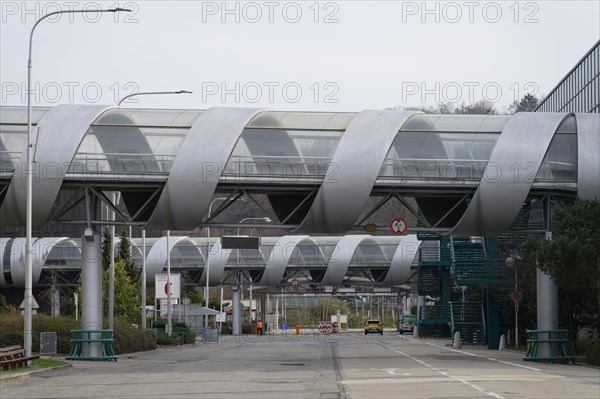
0 104 600 236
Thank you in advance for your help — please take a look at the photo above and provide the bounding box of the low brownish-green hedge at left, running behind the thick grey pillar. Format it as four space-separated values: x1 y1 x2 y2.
0 314 156 354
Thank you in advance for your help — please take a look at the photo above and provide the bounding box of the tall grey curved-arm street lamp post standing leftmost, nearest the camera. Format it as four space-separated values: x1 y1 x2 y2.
23 7 131 356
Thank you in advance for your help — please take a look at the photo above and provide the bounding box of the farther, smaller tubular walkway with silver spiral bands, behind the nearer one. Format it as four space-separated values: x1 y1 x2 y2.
0 235 421 288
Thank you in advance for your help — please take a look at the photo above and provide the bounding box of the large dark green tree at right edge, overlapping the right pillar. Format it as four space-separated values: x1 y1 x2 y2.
521 199 600 334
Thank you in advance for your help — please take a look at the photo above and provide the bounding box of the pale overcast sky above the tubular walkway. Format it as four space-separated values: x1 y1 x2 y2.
0 0 600 111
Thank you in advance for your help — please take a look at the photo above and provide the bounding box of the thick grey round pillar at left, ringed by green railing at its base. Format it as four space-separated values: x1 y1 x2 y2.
81 231 102 356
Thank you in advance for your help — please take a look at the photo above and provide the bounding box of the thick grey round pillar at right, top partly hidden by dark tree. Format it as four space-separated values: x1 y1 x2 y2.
536 269 558 357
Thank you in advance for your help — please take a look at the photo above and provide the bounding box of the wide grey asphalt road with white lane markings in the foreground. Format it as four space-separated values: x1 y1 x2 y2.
0 331 600 399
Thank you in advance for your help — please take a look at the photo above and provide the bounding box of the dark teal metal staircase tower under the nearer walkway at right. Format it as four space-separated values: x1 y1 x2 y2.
417 234 511 347
